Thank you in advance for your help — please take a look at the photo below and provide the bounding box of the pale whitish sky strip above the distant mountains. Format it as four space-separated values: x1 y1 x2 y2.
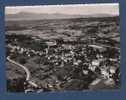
5 3 119 15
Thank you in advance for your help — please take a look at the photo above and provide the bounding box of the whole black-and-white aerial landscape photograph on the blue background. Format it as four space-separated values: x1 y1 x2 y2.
5 3 121 94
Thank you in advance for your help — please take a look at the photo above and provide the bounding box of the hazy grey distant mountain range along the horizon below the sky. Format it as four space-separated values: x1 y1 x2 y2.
5 12 117 20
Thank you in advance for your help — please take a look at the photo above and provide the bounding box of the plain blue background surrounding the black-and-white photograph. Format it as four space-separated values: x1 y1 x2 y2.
0 0 126 100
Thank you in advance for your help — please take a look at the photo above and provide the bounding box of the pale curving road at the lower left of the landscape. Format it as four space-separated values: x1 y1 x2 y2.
7 57 38 87
